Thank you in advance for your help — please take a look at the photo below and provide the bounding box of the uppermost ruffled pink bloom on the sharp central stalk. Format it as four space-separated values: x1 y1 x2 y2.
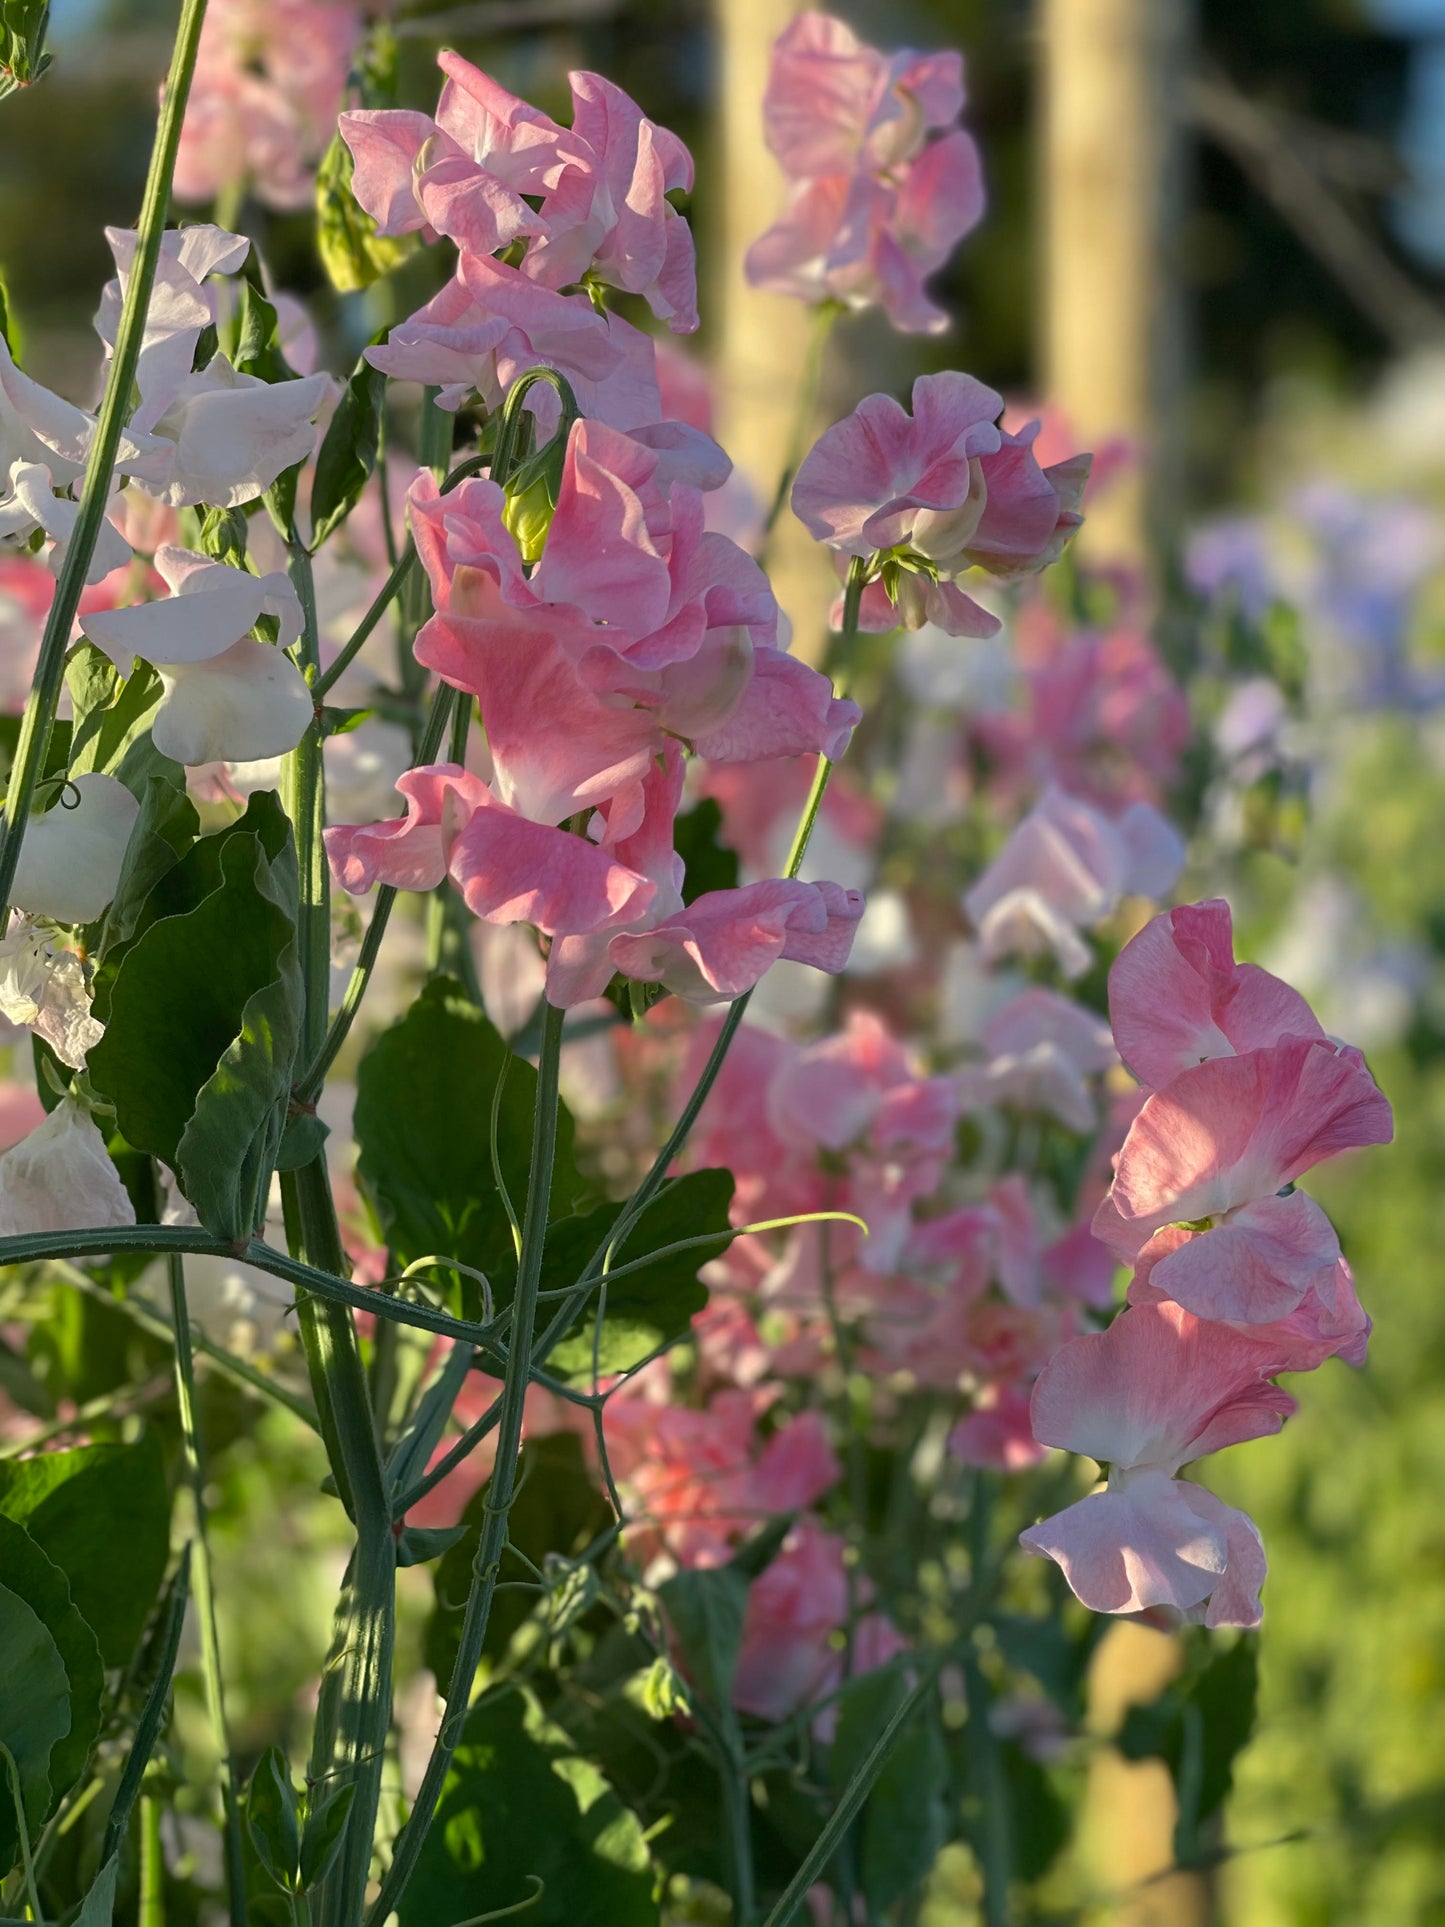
341 50 697 333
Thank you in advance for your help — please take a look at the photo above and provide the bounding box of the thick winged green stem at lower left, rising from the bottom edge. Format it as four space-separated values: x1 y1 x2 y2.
281 1156 397 1927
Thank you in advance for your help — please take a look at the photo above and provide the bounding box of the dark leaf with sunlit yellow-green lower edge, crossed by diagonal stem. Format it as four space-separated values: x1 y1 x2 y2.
541 1170 732 1380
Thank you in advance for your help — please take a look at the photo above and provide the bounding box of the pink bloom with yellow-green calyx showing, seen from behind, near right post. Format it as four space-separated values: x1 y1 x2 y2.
792 374 1089 636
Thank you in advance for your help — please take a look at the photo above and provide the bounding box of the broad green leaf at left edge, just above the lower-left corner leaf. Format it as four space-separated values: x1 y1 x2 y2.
0 1432 171 1667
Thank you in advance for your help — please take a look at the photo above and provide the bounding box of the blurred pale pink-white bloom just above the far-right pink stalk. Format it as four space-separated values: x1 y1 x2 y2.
963 788 1185 977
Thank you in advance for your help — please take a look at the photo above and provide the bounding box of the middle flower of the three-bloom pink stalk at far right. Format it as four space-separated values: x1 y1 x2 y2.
1094 1037 1393 1324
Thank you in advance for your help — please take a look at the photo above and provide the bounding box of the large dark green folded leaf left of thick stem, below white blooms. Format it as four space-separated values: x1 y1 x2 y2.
89 796 302 1239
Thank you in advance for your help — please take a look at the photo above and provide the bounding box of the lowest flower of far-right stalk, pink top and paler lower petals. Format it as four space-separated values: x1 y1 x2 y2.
1019 1305 1295 1626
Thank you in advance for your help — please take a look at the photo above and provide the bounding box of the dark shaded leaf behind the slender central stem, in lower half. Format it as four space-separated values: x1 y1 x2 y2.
426 1432 611 1694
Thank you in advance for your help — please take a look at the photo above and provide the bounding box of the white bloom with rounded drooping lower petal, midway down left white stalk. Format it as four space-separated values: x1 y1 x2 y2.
85 545 314 767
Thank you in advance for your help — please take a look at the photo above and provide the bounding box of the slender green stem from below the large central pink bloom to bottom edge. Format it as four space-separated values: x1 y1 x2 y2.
366 1004 563 1927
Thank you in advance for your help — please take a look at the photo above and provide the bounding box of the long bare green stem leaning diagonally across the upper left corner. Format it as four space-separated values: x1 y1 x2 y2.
0 0 206 931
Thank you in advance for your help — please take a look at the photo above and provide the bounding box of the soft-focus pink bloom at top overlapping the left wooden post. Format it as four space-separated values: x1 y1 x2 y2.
746 13 985 333
